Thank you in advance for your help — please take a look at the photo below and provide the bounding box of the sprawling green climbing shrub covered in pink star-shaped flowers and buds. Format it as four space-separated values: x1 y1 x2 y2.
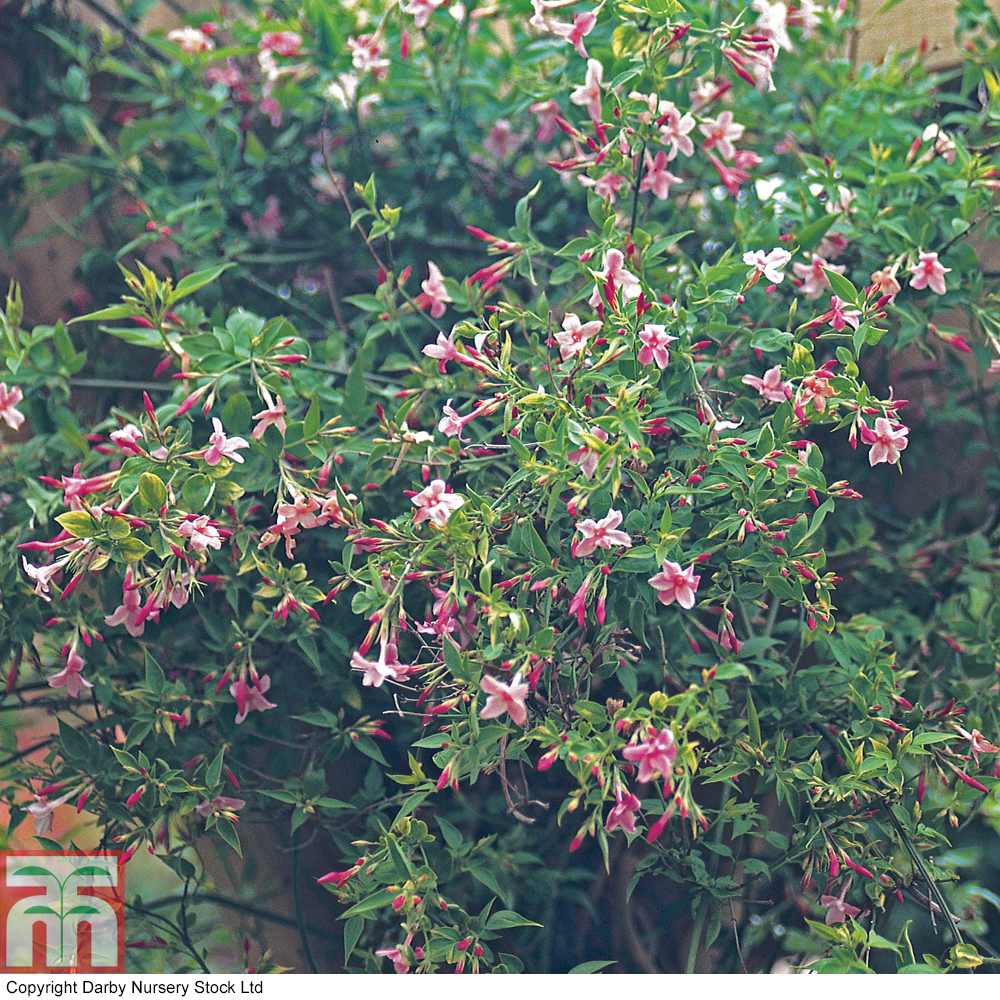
0 0 1000 972
